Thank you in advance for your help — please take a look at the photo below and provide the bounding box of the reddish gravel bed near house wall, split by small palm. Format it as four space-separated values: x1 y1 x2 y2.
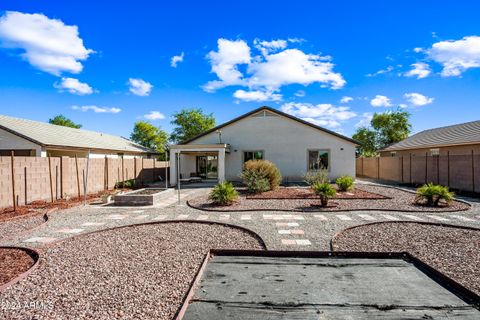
246 187 387 199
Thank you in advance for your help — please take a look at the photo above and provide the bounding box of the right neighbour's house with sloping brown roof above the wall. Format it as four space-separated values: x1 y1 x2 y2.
380 120 480 157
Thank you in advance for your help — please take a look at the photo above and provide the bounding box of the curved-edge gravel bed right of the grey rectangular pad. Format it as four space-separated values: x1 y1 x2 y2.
333 222 480 294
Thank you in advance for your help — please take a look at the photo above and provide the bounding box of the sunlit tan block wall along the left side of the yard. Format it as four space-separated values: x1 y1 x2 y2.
0 156 168 208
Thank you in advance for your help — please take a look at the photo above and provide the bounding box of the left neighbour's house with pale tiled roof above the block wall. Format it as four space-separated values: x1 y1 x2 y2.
0 115 155 158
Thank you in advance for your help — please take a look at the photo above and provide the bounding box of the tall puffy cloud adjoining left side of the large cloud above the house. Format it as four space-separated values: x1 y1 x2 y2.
203 39 251 92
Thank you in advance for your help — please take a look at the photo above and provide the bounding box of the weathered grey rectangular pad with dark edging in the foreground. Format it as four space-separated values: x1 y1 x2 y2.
183 255 480 320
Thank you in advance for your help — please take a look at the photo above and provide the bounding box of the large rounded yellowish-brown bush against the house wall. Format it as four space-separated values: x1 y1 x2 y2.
241 160 282 193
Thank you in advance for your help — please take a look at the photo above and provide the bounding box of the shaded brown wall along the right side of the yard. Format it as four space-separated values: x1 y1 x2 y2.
356 152 480 192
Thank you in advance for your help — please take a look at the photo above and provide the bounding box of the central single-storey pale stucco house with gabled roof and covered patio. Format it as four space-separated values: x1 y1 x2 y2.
170 107 358 184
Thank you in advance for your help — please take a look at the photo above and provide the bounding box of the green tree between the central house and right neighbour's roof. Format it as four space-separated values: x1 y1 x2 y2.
352 109 412 157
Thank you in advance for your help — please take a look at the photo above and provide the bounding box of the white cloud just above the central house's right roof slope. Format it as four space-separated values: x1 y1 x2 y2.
281 102 357 128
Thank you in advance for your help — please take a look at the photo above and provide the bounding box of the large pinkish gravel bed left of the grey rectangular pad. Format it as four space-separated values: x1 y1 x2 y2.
0 222 264 319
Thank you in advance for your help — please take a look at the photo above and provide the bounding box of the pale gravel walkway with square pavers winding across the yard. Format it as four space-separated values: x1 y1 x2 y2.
0 180 480 250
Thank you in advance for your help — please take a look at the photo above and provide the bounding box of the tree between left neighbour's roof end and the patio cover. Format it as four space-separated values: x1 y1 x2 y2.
130 121 168 159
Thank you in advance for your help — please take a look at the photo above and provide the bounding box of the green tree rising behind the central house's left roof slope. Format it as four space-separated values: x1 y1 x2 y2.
170 109 215 143
